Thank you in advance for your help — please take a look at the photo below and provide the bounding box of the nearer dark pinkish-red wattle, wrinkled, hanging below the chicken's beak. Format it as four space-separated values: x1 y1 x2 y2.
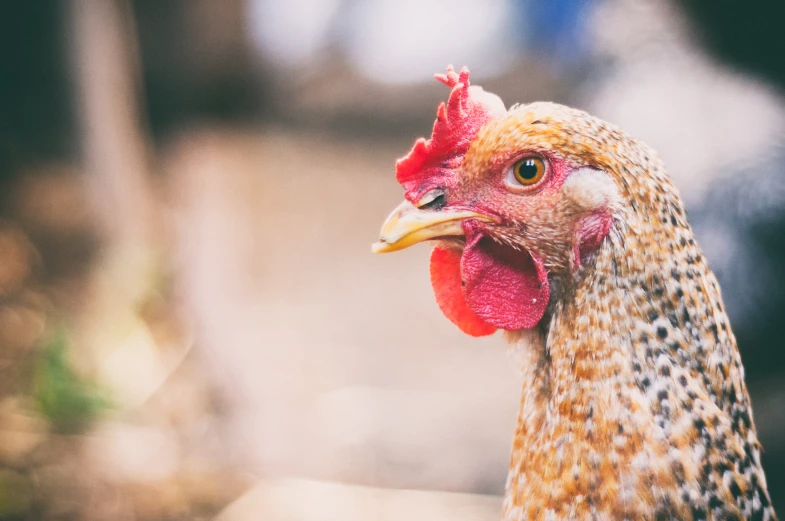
461 226 550 331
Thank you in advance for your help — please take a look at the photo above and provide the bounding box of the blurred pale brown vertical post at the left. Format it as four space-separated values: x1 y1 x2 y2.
69 0 175 406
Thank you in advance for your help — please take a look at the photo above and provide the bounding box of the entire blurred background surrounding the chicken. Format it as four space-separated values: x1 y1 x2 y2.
0 0 785 521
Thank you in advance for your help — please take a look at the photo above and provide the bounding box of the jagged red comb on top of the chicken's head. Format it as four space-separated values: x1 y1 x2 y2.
395 65 505 200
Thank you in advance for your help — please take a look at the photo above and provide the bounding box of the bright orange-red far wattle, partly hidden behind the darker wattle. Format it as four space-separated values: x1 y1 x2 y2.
431 246 496 336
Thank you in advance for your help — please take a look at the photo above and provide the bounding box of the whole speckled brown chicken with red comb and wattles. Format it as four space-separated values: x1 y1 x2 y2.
373 67 776 521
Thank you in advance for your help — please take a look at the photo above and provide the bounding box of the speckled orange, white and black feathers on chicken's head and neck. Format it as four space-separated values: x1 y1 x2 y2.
462 103 776 521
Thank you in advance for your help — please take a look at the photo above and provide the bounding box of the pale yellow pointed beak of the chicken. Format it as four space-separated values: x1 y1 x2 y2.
371 201 493 253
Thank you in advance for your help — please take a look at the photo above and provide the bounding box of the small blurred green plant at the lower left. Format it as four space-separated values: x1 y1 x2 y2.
34 329 112 434
